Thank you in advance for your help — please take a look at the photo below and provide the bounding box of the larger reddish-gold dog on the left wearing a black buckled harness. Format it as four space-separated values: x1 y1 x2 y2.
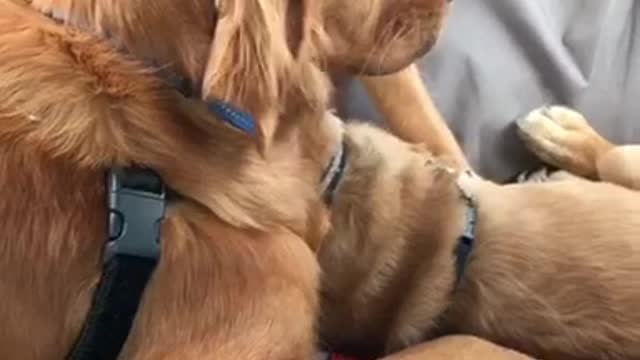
0 0 460 360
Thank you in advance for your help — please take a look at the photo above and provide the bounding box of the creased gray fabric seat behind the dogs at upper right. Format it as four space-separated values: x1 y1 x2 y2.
338 0 640 180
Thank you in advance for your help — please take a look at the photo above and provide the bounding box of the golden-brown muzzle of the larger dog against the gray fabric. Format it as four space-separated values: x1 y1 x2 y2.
323 0 448 75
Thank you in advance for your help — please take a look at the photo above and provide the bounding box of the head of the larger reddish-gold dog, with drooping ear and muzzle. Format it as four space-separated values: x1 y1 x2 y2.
31 0 447 148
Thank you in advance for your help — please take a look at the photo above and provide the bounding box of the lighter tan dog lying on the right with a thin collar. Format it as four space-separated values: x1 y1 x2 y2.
319 107 640 359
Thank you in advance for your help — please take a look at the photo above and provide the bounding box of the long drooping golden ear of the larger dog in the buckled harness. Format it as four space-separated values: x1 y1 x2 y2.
202 0 320 152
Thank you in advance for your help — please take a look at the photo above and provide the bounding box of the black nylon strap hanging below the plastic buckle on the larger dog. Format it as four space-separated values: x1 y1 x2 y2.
69 255 157 360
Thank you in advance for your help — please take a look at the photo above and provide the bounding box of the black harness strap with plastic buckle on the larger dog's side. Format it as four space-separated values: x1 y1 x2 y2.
68 169 166 360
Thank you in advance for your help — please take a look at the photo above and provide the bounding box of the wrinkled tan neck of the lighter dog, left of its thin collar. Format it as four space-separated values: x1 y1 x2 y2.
320 143 466 355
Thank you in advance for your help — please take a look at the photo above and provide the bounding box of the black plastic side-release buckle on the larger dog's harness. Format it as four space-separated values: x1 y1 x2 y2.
104 168 166 262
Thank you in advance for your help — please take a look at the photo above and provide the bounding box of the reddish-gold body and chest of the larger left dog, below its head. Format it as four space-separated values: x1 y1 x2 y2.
0 1 338 359
